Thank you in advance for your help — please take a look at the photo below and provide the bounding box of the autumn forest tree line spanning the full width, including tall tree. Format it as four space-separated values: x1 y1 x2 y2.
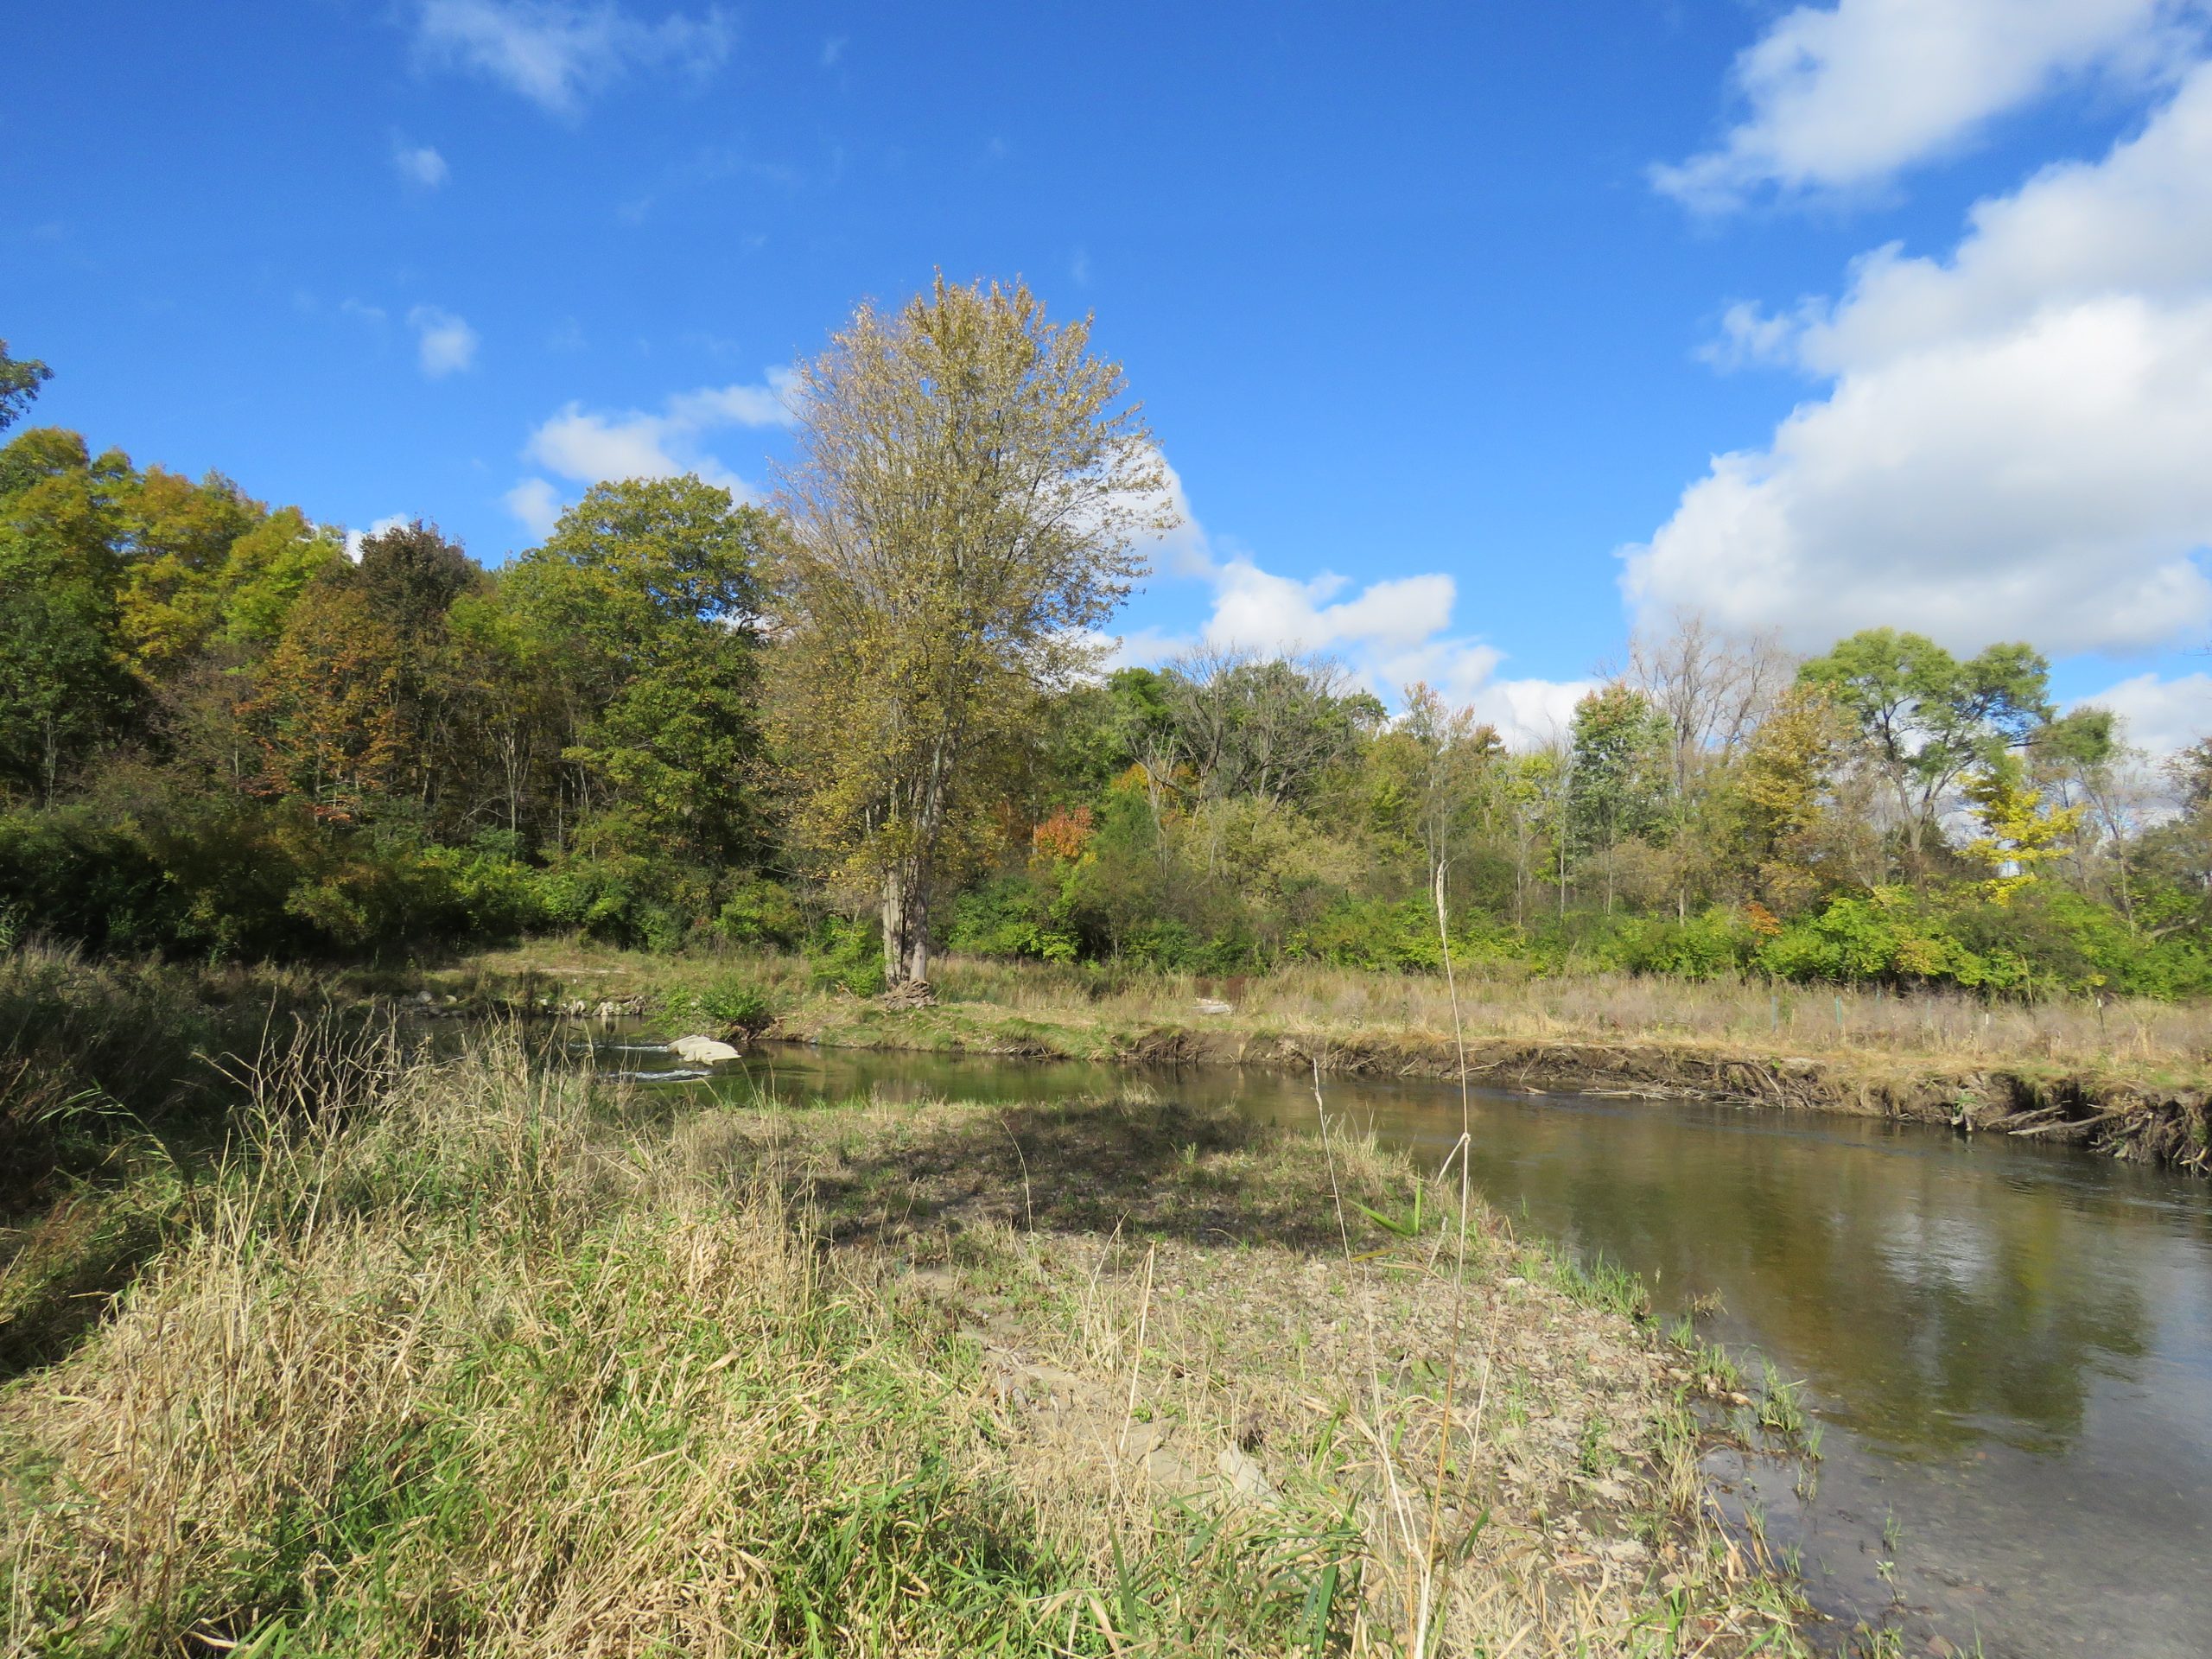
0 296 2212 995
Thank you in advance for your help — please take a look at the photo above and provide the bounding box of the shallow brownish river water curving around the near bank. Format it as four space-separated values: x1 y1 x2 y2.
566 1038 2212 1659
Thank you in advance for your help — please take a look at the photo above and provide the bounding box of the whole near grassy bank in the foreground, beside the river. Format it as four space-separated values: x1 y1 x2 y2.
0 1038 1796 1655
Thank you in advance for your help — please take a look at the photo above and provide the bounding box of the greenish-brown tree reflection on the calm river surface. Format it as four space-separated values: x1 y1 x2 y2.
1247 1086 2174 1458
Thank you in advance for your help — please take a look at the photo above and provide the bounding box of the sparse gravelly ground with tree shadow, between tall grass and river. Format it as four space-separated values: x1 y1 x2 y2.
690 1096 1798 1652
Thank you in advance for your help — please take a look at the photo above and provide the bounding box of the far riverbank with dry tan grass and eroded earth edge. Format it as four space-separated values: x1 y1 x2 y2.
410 944 2212 1174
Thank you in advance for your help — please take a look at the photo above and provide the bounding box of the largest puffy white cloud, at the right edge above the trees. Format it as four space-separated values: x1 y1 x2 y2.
1624 67 2212 651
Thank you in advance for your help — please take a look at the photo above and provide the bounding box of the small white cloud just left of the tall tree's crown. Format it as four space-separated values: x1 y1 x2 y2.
506 367 791 536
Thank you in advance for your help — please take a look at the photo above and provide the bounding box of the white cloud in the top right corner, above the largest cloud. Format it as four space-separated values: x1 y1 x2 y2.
1652 0 2201 210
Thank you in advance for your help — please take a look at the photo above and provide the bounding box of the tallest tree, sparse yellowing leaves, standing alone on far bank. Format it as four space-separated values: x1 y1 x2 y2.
783 276 1174 982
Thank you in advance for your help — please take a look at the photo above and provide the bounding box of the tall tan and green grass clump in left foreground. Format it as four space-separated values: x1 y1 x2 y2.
0 1044 1092 1655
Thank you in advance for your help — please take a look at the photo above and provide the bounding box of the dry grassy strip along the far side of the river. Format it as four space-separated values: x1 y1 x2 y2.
403 947 2212 1177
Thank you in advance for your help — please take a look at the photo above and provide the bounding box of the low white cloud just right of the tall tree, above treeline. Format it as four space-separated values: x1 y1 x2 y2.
1113 473 1595 746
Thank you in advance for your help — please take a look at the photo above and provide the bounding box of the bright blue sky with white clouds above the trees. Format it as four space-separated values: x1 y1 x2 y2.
13 0 2212 746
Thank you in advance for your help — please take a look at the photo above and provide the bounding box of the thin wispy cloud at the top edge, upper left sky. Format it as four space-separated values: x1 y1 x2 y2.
416 0 732 115
